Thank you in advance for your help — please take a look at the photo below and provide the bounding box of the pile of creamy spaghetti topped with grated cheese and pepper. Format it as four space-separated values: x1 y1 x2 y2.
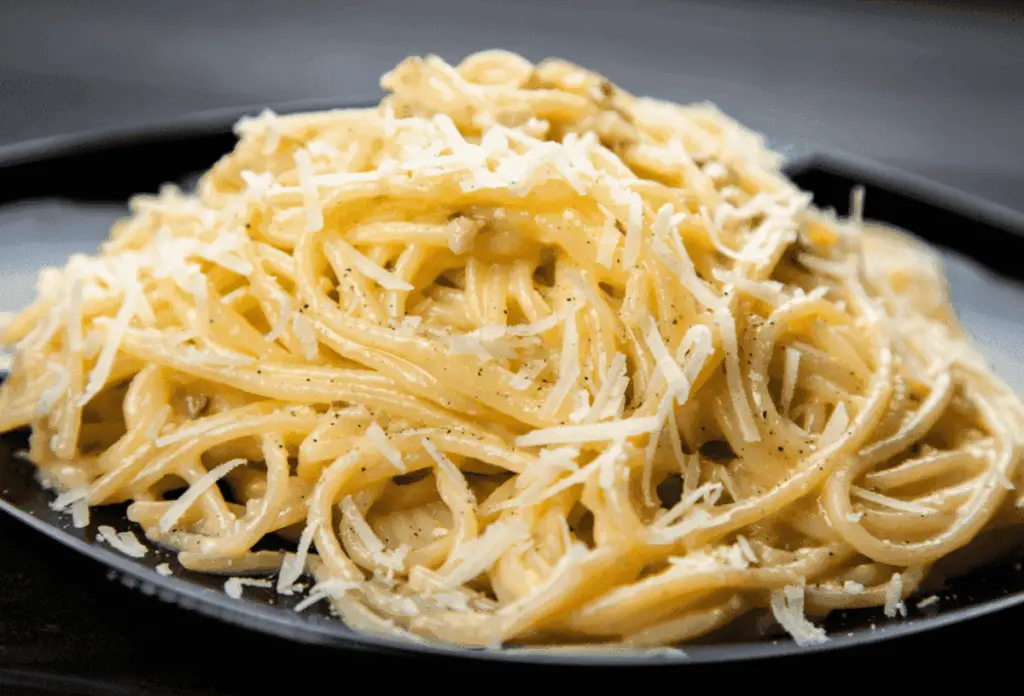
0 51 1024 646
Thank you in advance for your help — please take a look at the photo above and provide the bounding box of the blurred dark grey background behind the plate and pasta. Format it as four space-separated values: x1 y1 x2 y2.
0 0 1024 210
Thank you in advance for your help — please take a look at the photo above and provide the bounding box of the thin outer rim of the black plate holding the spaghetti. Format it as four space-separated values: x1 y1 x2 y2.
0 105 1024 666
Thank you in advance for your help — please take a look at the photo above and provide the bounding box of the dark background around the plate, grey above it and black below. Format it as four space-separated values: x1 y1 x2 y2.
0 0 1024 694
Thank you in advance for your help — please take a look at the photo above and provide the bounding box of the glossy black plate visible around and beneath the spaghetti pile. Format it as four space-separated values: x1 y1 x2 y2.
0 99 1024 664
